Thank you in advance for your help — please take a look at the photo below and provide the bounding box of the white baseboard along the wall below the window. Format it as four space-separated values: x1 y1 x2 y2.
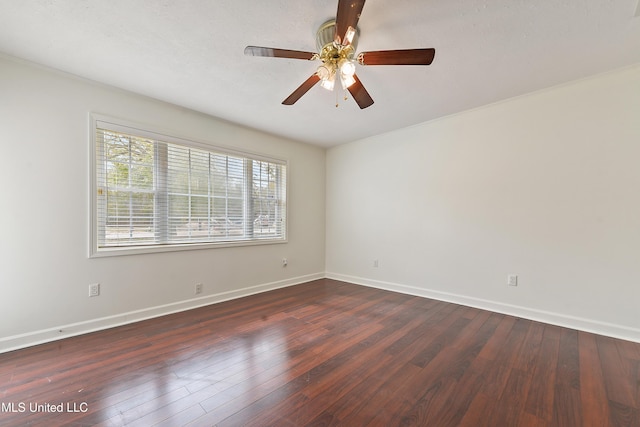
0 273 325 353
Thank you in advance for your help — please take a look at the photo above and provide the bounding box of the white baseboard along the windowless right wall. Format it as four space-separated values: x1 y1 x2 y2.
326 272 640 343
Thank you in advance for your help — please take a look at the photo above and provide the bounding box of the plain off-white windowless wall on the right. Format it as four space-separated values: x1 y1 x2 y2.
326 66 640 341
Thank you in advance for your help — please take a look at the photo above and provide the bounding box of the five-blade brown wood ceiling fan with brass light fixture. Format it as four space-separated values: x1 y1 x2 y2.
244 0 436 108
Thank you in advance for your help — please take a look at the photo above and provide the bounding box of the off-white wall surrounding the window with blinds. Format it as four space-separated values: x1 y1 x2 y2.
0 57 325 351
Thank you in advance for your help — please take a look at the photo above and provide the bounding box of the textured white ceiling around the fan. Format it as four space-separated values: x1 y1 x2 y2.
0 0 640 146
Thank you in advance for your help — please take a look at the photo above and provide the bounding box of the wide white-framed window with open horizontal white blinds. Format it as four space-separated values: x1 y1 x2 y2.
91 117 287 255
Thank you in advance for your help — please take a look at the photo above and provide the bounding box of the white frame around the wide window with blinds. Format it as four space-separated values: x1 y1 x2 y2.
89 113 289 258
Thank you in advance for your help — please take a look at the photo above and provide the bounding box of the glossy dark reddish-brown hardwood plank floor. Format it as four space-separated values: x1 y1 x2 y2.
0 280 640 427
